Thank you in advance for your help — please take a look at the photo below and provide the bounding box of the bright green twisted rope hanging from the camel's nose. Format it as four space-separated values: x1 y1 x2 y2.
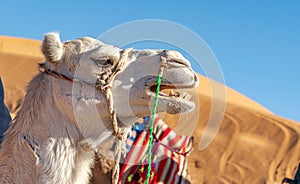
146 73 162 184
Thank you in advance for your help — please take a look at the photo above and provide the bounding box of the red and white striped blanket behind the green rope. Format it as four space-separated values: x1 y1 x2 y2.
119 117 193 184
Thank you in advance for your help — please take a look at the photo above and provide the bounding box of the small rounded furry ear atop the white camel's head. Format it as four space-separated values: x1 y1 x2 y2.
42 33 64 63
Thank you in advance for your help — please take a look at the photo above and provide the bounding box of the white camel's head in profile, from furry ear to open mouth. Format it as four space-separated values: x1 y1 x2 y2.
42 33 198 127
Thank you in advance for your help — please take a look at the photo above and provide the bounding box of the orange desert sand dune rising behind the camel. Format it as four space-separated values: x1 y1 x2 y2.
0 36 300 184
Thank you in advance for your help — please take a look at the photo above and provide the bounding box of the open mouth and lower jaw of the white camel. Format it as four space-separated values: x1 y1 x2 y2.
146 84 195 114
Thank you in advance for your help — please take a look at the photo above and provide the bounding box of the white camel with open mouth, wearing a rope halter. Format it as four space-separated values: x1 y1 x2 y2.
0 33 198 184
